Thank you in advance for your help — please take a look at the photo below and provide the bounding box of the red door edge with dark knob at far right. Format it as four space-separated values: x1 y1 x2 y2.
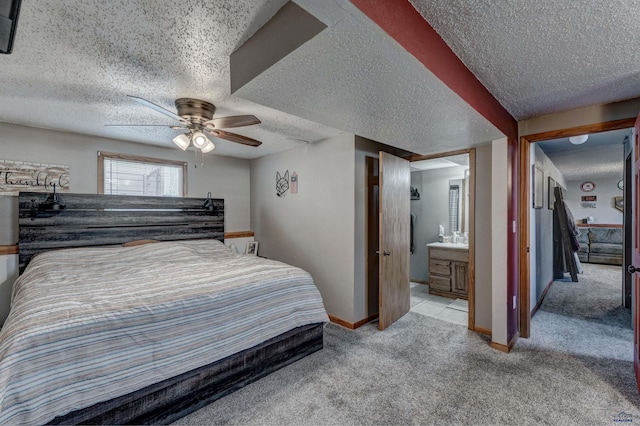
625 111 640 392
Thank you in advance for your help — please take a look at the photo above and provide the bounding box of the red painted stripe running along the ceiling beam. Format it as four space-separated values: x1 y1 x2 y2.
351 0 518 138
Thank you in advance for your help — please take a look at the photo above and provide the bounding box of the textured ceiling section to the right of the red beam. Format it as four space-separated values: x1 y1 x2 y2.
410 0 640 120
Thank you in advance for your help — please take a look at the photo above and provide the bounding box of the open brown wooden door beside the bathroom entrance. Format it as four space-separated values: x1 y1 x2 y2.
378 152 411 330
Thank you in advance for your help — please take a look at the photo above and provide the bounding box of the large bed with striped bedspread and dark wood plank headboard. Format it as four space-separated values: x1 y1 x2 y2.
0 193 328 424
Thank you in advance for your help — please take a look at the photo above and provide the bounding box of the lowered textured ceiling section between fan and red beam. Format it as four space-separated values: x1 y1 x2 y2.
235 0 503 154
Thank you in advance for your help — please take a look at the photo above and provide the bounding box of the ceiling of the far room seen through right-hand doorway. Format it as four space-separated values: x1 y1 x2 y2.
536 129 631 181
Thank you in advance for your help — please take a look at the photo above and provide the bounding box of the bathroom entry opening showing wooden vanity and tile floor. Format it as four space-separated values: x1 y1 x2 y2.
410 150 475 329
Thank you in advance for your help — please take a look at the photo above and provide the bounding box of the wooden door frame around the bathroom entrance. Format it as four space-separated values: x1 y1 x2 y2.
405 148 478 335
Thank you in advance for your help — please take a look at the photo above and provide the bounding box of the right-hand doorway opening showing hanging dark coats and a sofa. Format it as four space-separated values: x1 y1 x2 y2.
529 129 631 334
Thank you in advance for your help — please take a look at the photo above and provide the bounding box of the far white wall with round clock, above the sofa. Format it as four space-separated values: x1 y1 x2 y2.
564 177 624 225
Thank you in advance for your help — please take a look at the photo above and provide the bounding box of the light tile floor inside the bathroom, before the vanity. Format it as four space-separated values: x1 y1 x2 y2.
411 283 469 325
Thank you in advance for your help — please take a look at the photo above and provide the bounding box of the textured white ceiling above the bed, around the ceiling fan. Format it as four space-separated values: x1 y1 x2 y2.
0 0 339 158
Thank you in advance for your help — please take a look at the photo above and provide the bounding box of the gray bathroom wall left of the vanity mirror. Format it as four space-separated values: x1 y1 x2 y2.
411 166 466 281
